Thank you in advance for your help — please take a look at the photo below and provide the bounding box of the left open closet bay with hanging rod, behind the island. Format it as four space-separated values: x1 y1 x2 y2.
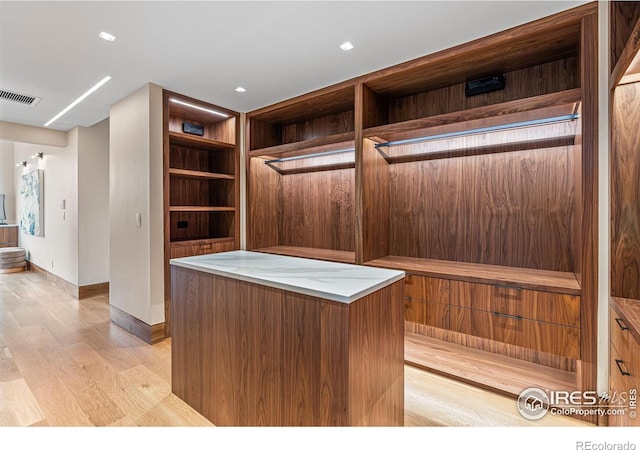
247 86 356 263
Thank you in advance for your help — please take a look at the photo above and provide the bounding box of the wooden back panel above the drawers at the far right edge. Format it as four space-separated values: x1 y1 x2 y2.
611 83 640 299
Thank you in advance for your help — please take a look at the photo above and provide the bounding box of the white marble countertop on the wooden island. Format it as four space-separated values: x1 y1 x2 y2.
170 250 404 303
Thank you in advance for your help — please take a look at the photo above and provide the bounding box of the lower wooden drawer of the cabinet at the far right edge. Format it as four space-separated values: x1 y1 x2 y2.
608 345 640 426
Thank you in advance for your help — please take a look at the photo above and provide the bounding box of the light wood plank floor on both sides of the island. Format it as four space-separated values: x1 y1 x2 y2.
0 272 586 427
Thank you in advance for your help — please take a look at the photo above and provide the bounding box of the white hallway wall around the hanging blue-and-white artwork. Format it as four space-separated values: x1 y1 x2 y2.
12 137 78 285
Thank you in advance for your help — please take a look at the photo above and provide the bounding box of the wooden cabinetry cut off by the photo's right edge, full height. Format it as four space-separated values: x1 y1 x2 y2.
609 2 640 426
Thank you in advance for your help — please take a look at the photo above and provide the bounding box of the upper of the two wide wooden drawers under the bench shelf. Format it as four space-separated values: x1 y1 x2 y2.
450 281 580 327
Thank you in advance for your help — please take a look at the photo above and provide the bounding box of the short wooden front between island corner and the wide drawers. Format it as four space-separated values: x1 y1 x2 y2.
404 274 449 329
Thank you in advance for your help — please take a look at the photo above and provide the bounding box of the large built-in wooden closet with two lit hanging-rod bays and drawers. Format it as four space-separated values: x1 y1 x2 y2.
247 3 598 414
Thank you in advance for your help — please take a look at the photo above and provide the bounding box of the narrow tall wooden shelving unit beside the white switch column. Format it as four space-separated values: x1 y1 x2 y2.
164 91 240 335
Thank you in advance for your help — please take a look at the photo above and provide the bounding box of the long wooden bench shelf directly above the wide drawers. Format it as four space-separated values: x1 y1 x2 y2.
366 256 581 295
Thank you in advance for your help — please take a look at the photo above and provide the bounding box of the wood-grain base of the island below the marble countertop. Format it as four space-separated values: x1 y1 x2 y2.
171 267 404 426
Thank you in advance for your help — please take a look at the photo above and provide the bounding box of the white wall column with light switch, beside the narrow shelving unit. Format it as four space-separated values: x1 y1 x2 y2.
109 84 164 325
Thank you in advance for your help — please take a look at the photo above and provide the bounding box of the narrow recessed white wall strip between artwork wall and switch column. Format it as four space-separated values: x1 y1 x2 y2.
78 119 109 286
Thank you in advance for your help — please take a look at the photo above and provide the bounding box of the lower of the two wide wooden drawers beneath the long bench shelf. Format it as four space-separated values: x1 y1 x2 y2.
450 306 580 359
